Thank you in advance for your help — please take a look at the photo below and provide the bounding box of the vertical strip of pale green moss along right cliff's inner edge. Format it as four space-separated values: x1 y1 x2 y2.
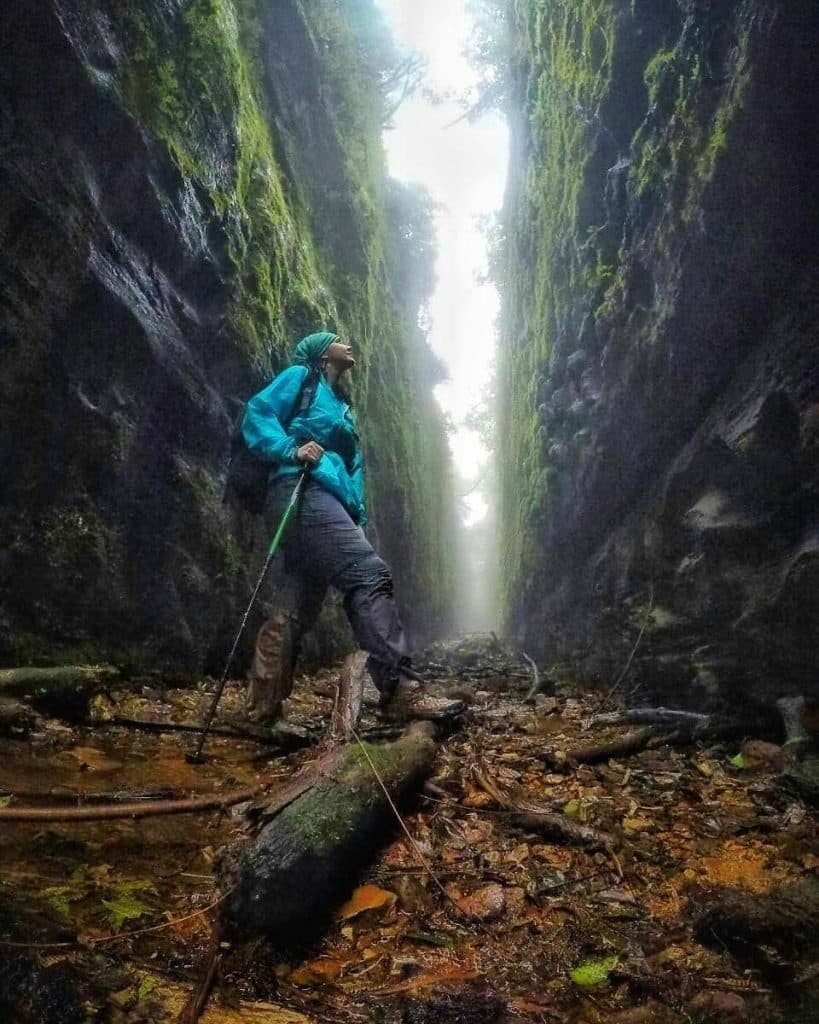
499 0 619 617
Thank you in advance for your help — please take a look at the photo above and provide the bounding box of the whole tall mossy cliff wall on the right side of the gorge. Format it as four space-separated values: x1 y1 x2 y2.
500 0 819 701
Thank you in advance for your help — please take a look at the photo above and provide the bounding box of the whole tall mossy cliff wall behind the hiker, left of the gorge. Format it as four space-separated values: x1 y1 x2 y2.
0 0 451 667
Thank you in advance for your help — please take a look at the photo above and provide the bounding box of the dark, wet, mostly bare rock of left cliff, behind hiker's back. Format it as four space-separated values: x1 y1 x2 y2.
0 4 240 663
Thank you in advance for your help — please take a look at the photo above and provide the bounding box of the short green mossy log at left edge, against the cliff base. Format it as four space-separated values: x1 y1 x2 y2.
0 665 119 720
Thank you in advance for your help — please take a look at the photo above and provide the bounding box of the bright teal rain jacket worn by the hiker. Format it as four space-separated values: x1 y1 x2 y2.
242 366 367 526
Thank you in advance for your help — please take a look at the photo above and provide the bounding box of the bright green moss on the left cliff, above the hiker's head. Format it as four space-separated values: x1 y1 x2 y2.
118 0 334 370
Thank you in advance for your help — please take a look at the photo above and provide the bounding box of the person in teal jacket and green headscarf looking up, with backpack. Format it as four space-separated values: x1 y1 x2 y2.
242 331 427 720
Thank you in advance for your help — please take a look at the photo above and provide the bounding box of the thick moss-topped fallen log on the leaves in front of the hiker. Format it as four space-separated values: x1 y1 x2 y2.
222 723 435 943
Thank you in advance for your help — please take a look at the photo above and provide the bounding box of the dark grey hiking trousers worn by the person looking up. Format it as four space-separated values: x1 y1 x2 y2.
265 475 407 689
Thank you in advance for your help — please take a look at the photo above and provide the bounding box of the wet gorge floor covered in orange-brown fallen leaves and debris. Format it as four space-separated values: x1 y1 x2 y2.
0 644 819 1024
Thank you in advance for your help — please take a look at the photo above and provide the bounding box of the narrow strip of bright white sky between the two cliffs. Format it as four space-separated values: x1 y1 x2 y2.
377 0 508 522
